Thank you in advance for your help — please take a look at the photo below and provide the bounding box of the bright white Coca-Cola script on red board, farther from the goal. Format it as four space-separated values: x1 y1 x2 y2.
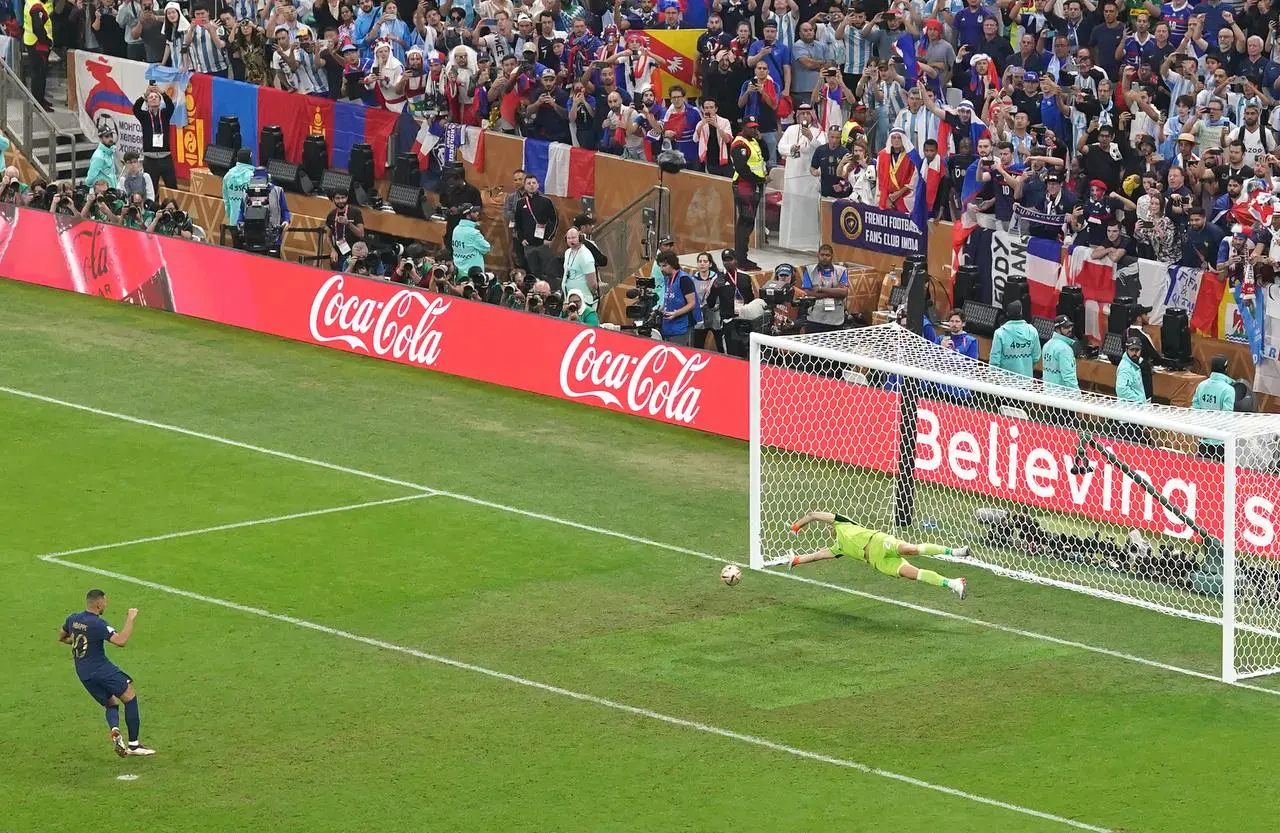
310 275 451 367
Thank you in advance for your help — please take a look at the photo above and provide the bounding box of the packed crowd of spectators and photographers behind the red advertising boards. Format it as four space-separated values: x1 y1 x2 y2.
17 0 1280 388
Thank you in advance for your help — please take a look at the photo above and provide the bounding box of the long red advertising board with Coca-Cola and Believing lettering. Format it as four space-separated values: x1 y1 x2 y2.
0 206 1280 549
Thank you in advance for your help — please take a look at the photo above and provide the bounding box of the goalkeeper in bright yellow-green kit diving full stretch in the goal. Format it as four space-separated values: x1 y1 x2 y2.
764 512 969 599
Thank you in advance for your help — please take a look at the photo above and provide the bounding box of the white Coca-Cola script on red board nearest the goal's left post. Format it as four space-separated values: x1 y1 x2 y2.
559 329 710 425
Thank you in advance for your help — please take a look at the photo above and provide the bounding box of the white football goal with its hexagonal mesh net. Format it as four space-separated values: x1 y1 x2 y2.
751 324 1280 681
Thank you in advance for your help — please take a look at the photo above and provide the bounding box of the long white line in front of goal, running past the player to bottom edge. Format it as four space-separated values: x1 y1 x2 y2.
42 555 1111 833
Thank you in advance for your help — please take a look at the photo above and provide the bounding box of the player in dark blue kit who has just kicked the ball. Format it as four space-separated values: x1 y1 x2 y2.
58 590 155 758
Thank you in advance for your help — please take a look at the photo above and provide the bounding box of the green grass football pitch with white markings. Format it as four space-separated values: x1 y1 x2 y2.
0 282 1280 833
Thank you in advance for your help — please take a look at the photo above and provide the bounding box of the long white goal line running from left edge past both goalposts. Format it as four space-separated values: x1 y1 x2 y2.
10 385 1280 696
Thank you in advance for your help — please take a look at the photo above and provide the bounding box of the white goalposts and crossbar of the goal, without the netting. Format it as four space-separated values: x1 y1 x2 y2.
749 324 1254 683
